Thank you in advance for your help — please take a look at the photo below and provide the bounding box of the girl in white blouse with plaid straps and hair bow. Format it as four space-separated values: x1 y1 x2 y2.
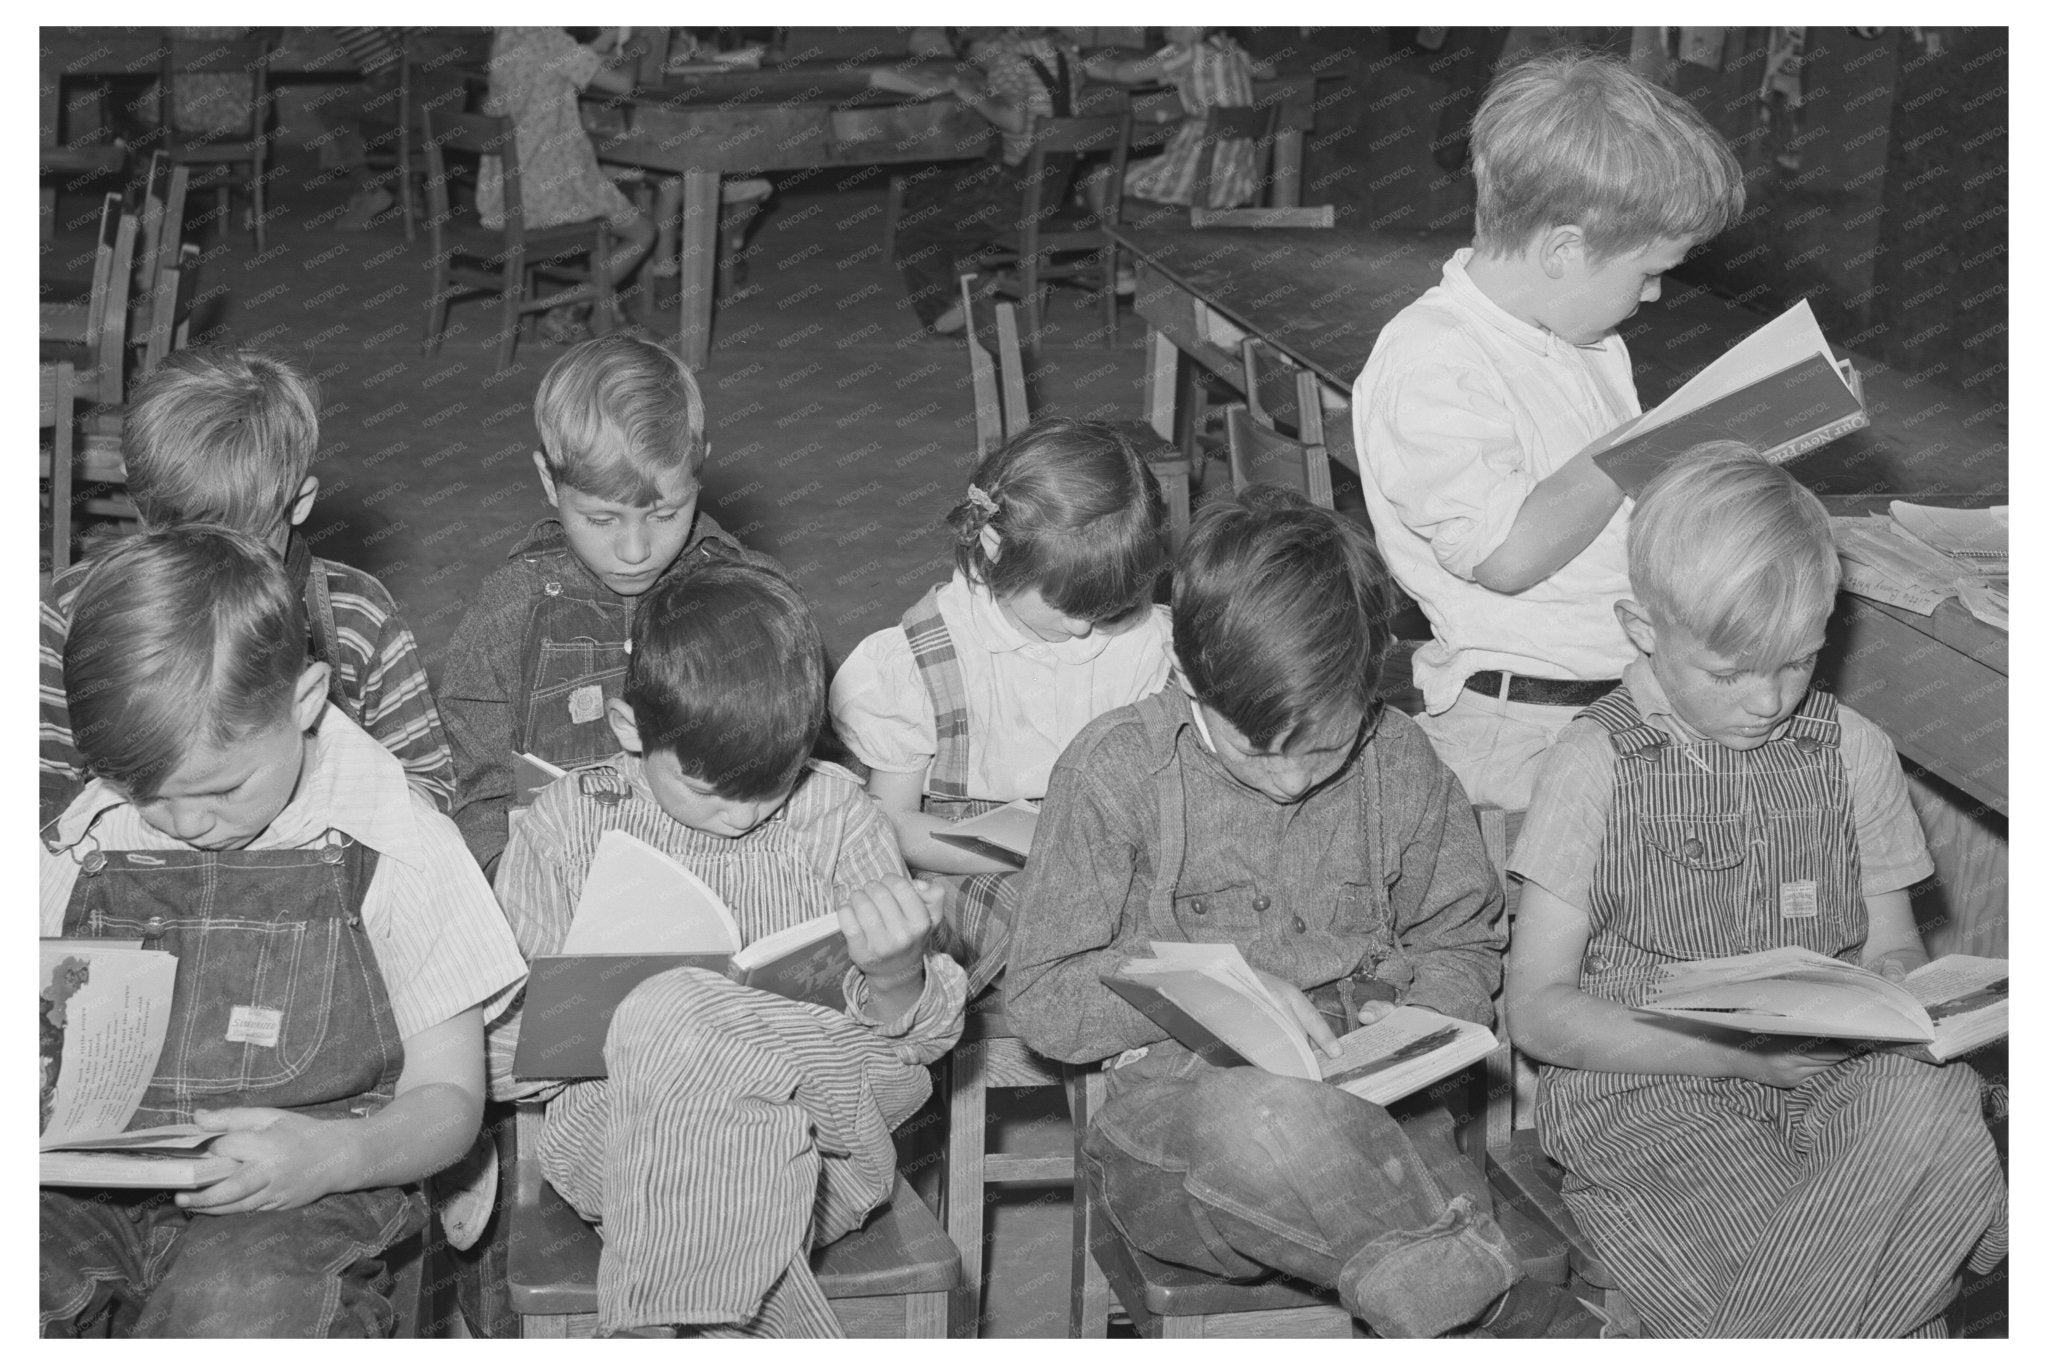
831 417 1174 984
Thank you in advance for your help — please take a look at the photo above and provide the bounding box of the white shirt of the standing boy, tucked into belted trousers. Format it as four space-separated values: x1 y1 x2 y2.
1352 248 1640 714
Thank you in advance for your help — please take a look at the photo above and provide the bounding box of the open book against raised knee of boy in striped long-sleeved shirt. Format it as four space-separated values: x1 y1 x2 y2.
512 829 852 1081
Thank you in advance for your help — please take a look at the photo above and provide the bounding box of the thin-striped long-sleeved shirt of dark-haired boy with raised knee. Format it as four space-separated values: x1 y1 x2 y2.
487 753 967 1099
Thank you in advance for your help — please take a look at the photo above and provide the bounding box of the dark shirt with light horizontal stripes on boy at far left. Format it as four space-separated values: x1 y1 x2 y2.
37 557 455 825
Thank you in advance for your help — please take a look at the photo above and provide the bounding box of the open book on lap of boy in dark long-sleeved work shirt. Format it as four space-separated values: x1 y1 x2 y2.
1104 939 1499 1105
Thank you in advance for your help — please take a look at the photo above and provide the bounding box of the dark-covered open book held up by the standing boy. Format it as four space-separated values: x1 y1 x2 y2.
1591 299 1870 495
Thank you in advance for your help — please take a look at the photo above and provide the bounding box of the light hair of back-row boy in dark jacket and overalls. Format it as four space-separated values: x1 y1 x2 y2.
532 336 705 508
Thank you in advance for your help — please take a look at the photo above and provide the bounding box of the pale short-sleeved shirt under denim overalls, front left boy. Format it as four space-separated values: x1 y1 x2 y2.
41 702 526 1038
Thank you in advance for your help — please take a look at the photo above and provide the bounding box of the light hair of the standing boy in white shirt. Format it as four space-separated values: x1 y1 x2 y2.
1473 51 1743 264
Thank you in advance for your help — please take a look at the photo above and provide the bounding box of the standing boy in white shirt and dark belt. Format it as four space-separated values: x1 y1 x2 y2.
1352 53 1743 810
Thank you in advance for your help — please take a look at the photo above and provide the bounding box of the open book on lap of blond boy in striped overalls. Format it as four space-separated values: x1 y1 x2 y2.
1640 948 2009 1062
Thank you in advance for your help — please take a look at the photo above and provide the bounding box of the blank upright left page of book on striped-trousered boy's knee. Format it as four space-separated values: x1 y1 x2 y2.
561 829 741 956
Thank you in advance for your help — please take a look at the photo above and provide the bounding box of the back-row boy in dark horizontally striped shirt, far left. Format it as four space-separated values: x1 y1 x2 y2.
39 348 455 825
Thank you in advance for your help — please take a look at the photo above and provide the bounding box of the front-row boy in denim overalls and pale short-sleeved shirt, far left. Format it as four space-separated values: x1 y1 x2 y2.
39 526 524 1336
